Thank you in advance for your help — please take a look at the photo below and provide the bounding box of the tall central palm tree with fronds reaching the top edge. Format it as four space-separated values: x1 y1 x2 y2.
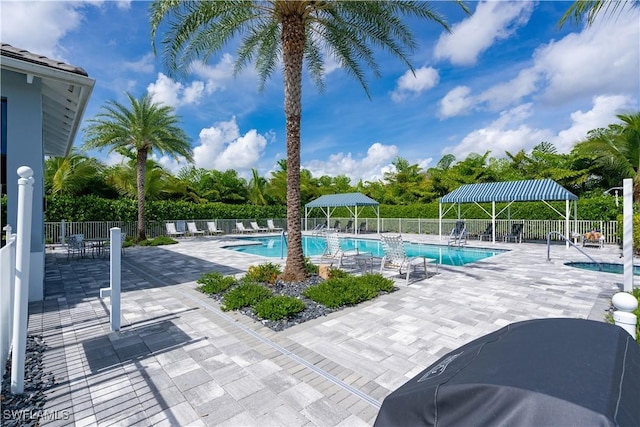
151 0 460 280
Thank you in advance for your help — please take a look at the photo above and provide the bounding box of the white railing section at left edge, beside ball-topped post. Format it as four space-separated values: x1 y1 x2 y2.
0 226 16 376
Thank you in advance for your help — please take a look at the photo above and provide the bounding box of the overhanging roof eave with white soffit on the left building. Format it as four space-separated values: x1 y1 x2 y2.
0 43 95 156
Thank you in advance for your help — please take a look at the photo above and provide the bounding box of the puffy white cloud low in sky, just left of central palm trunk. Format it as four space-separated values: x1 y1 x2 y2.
193 117 267 175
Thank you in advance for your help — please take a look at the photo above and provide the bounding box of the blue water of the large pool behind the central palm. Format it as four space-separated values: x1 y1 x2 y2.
227 236 507 265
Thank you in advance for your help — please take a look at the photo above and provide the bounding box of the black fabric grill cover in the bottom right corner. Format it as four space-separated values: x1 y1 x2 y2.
374 319 640 427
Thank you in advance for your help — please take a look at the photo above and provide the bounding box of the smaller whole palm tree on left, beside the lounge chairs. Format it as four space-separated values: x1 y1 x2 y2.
84 93 193 241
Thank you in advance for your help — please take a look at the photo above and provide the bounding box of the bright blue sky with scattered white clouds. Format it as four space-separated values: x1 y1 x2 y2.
0 0 640 184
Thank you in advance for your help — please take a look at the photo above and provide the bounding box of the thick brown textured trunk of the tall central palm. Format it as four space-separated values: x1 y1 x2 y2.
282 14 307 281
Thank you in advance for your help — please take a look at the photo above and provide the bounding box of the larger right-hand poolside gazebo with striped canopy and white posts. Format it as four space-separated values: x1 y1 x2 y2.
438 179 578 246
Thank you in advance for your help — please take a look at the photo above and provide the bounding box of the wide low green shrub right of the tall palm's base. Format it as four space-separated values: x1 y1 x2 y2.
303 274 393 308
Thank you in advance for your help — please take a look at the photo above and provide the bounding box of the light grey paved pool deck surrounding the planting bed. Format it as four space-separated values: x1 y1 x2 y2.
23 234 637 426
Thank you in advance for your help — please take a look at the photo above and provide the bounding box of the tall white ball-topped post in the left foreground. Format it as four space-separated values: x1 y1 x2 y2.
11 166 34 394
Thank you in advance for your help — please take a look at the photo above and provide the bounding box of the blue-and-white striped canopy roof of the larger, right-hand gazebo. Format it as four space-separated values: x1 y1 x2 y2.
440 179 578 203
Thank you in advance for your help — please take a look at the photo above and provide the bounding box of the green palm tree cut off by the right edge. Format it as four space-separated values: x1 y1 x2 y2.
574 112 640 200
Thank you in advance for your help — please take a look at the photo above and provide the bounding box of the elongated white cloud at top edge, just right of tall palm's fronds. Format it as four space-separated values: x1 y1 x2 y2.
434 1 534 65
